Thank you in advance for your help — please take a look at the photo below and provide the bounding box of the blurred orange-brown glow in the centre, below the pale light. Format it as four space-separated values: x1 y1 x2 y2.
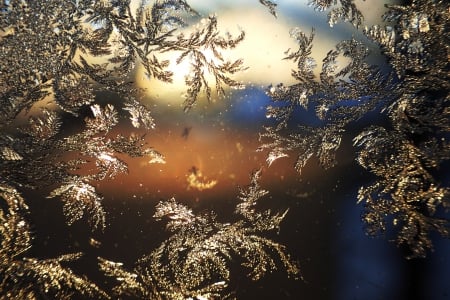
100 116 324 203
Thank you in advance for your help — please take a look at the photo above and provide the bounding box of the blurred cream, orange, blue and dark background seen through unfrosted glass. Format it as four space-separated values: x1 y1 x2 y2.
25 0 450 300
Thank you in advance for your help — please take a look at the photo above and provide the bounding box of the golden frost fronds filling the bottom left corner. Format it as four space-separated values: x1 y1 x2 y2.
0 184 109 299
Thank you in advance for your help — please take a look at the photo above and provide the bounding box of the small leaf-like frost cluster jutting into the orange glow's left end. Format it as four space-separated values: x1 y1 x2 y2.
49 104 164 228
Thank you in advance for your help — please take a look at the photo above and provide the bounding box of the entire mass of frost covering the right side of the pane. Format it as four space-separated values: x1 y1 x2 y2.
259 1 450 257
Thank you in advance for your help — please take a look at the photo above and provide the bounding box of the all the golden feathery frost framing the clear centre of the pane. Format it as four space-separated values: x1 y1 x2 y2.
0 0 450 299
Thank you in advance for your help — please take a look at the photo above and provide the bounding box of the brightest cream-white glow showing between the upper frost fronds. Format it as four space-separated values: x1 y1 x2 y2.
135 9 302 104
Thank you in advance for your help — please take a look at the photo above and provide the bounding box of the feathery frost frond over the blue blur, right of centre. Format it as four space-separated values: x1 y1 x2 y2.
259 29 392 171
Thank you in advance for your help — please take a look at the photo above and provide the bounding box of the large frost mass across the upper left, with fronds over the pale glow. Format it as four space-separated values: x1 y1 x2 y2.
0 1 232 228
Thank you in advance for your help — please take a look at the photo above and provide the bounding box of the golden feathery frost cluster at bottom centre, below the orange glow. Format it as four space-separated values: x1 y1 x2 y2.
100 172 299 299
